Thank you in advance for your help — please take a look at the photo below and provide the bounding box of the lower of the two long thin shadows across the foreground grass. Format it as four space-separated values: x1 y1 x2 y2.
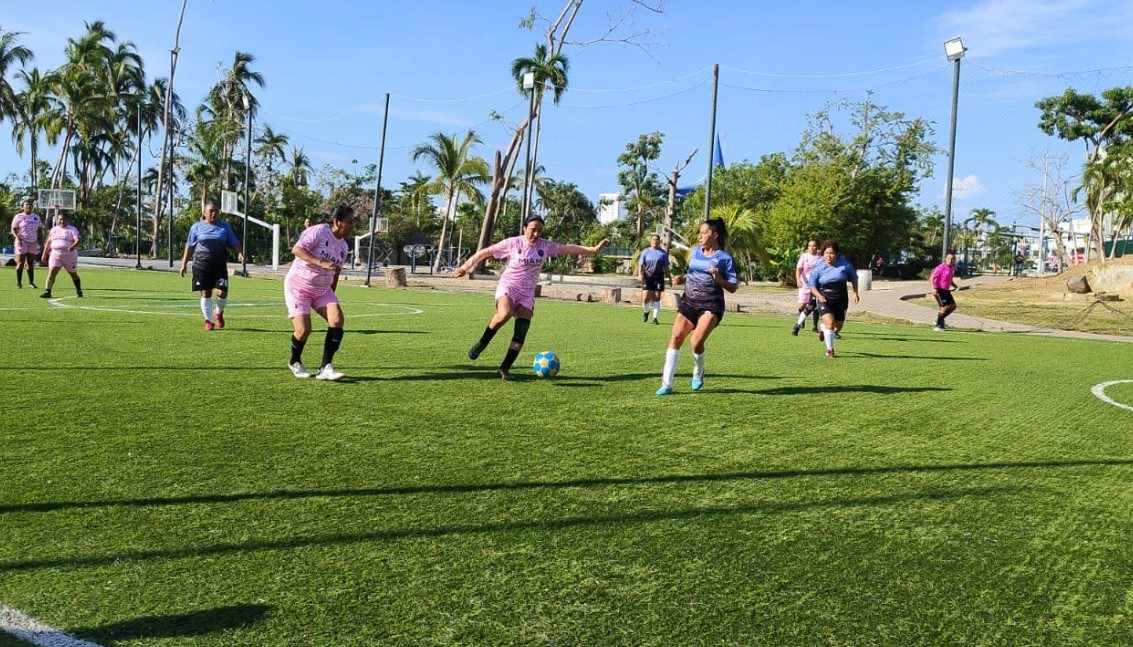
0 486 1025 571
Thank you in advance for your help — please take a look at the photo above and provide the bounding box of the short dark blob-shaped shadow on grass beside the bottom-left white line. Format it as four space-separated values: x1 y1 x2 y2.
69 604 272 647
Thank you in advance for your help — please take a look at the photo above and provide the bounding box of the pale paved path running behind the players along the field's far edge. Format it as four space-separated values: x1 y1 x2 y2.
48 257 1133 343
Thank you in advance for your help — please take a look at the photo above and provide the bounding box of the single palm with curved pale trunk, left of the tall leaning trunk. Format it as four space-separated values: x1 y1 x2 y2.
410 130 488 272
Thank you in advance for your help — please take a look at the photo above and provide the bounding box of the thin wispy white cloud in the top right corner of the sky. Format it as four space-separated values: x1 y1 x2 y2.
936 0 1133 57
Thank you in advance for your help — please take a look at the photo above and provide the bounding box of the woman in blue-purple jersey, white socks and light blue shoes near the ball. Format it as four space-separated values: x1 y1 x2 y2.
657 218 740 395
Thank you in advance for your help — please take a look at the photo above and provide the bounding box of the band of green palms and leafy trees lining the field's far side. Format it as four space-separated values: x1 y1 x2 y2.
0 21 1133 282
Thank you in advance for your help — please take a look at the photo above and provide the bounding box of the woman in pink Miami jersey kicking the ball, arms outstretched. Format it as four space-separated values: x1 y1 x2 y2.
452 215 610 381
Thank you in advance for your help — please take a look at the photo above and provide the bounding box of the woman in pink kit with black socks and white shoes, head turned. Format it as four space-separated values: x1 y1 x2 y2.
283 205 353 382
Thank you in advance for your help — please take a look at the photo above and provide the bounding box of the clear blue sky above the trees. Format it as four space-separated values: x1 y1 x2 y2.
0 0 1133 223
